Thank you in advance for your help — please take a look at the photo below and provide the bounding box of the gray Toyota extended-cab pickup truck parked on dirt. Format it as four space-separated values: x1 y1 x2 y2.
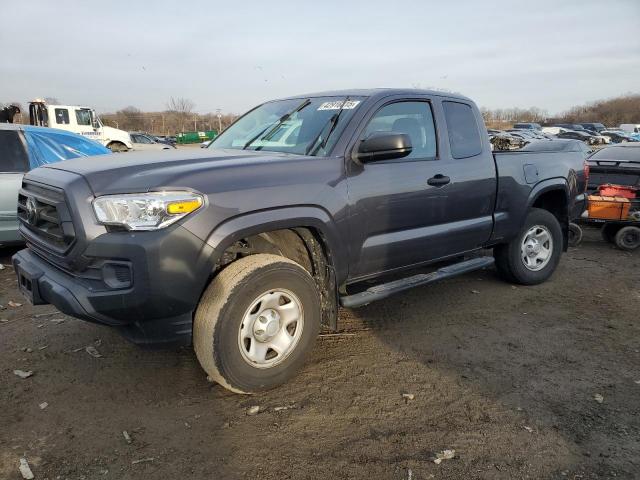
13 89 586 393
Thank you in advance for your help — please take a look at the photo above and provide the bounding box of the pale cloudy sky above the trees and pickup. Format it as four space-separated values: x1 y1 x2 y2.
0 0 640 114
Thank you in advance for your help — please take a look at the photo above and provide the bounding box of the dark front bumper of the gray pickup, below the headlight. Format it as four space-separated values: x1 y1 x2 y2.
13 226 212 345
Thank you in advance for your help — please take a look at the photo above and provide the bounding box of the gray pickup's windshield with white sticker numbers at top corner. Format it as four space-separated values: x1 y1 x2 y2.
209 97 363 156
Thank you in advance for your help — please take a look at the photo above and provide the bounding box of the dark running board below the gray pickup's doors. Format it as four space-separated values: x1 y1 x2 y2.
340 257 493 308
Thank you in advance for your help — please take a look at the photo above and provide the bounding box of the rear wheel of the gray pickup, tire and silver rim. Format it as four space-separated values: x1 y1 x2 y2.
494 208 563 285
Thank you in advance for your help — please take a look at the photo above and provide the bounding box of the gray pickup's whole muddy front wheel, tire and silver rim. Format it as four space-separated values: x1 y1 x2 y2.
193 254 321 393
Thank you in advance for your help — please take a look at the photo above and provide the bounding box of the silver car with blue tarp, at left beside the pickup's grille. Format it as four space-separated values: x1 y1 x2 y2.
0 123 111 245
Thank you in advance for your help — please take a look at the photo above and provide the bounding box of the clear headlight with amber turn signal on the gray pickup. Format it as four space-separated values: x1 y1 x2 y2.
93 192 204 230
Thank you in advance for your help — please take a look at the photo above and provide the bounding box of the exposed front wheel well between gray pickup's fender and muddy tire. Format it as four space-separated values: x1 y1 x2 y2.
212 227 338 330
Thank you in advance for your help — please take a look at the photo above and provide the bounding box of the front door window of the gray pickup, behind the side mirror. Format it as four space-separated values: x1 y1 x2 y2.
363 102 436 159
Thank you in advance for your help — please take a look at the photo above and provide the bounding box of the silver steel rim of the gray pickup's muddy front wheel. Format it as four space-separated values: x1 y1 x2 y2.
238 289 304 368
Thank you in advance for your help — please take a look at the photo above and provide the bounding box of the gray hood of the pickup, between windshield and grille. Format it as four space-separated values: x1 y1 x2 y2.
39 148 301 196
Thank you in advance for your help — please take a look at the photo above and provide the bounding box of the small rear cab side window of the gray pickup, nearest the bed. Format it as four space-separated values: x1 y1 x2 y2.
442 102 482 158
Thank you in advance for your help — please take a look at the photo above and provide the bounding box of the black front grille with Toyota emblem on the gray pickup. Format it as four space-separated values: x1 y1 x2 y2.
18 180 75 254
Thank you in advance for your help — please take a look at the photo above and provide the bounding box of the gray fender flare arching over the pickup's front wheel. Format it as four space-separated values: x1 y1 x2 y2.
206 206 348 283
